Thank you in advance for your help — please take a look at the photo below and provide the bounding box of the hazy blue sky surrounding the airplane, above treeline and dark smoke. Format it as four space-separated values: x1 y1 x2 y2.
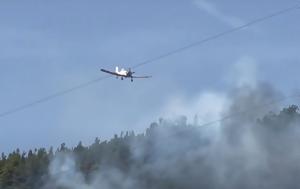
0 0 300 151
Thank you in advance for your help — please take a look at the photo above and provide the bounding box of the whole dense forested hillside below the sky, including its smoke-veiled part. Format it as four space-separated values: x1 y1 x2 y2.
0 105 300 189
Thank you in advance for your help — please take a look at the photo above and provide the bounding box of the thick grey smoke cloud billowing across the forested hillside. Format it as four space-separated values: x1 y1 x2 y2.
44 84 300 189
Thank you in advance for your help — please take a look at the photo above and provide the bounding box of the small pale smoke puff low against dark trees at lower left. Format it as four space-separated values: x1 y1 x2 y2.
43 152 135 189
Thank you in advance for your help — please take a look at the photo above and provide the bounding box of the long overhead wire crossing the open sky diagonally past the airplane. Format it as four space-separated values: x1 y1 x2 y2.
0 5 300 118
